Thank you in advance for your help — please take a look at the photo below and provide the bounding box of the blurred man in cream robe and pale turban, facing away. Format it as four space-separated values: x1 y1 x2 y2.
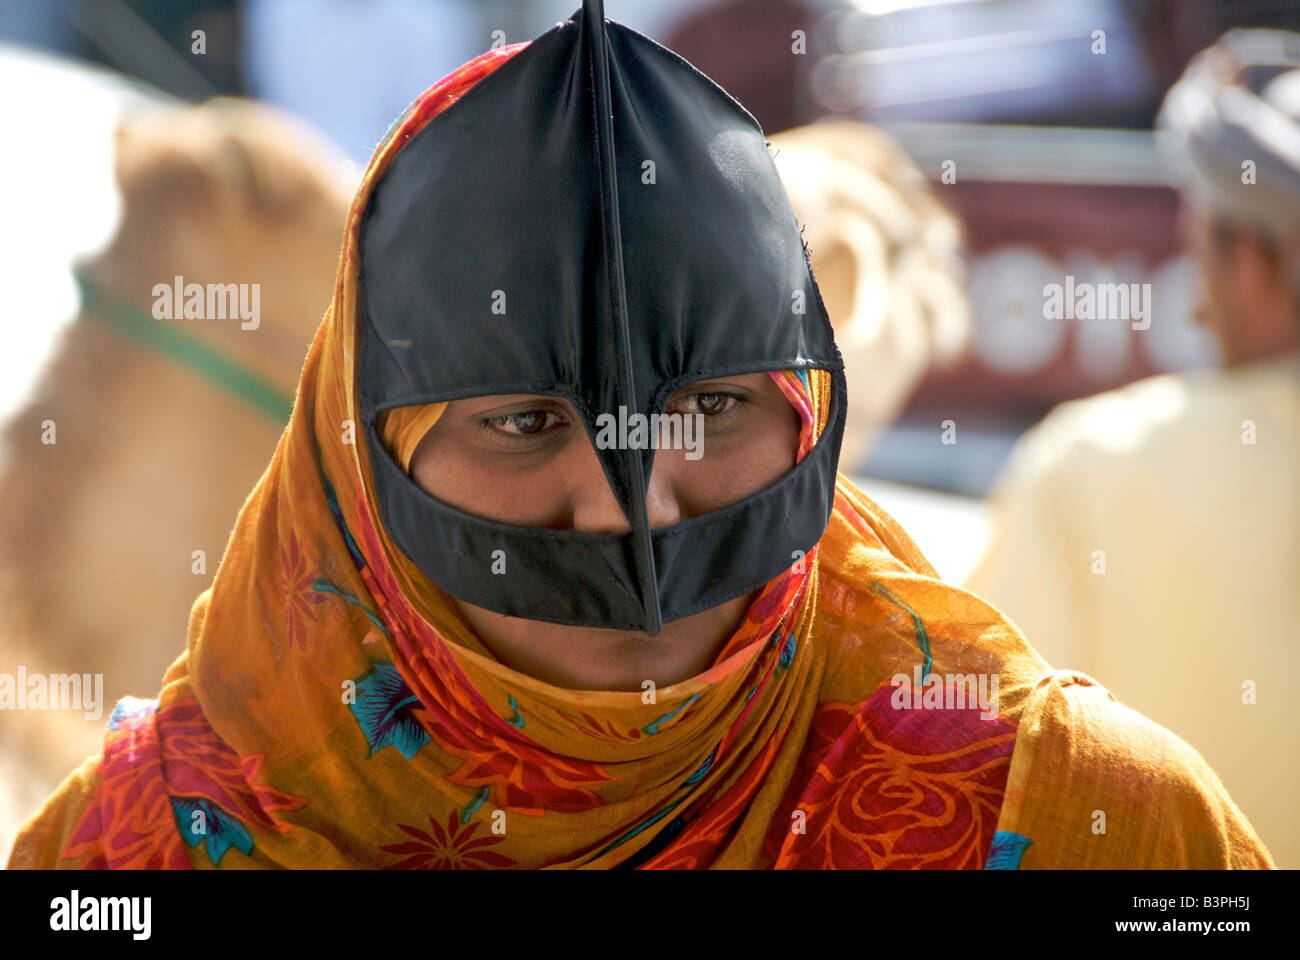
966 30 1300 868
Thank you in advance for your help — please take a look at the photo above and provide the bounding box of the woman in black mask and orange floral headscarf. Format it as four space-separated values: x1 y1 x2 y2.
12 4 1271 869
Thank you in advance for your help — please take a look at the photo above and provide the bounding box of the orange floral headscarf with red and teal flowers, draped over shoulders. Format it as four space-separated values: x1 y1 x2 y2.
10 44 1269 869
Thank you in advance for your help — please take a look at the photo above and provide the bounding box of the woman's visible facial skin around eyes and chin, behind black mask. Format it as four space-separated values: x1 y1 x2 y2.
411 373 800 691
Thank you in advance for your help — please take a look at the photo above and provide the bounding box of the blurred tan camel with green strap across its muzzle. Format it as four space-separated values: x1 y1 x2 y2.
0 98 355 862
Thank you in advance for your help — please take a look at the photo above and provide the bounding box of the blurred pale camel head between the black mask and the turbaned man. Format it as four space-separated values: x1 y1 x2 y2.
770 120 970 475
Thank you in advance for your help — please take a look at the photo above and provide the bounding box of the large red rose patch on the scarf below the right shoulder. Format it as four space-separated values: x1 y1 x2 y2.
764 684 1015 869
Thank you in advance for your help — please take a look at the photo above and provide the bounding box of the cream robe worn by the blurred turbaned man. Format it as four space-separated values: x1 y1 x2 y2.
965 354 1300 868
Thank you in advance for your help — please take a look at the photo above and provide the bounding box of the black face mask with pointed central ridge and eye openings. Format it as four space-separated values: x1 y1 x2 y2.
359 1 845 636
